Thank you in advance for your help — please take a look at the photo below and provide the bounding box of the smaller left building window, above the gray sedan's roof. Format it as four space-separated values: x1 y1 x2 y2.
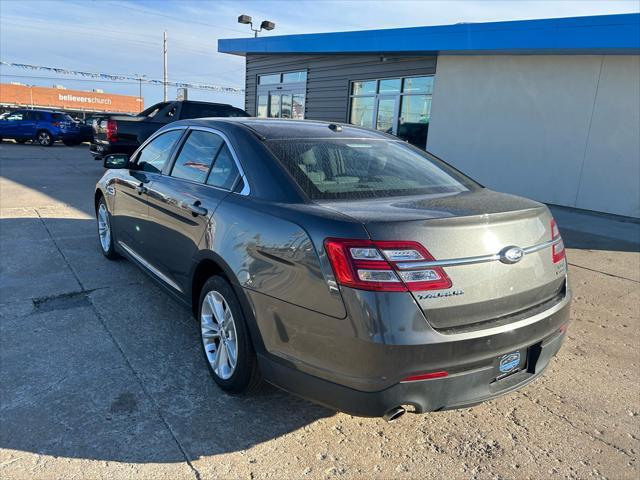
256 71 307 120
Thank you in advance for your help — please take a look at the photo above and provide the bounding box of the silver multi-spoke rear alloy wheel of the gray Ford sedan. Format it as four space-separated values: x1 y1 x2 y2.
200 290 238 380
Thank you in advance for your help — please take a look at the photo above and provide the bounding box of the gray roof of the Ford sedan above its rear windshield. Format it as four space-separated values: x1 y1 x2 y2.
180 117 398 140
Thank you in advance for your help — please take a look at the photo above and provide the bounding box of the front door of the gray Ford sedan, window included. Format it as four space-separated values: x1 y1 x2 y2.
113 129 184 255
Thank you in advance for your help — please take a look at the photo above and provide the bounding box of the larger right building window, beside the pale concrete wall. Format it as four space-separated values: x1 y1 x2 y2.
349 75 433 148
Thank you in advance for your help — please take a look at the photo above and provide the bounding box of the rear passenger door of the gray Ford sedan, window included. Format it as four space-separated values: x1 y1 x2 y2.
149 127 244 291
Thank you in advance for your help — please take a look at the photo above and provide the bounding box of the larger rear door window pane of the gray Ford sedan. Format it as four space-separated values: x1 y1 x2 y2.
171 130 224 183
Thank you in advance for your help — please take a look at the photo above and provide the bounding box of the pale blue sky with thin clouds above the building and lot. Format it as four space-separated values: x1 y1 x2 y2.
0 0 640 107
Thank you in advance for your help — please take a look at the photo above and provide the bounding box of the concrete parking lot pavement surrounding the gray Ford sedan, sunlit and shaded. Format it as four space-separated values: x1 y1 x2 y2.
0 142 640 479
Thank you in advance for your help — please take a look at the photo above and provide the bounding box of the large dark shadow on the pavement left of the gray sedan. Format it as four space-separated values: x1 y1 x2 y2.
0 216 334 463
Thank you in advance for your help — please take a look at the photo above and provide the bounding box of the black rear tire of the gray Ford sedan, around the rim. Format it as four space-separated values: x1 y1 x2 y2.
198 275 263 394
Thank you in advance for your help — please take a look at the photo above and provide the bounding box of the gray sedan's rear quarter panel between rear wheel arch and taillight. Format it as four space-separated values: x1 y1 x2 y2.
202 195 358 318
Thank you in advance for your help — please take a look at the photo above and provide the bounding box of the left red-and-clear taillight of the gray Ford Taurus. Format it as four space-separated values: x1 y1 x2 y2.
324 238 451 292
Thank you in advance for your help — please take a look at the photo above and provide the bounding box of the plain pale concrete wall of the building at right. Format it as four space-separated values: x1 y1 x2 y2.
427 55 640 218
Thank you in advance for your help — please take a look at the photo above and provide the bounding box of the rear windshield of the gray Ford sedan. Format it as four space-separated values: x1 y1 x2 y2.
267 139 478 200
